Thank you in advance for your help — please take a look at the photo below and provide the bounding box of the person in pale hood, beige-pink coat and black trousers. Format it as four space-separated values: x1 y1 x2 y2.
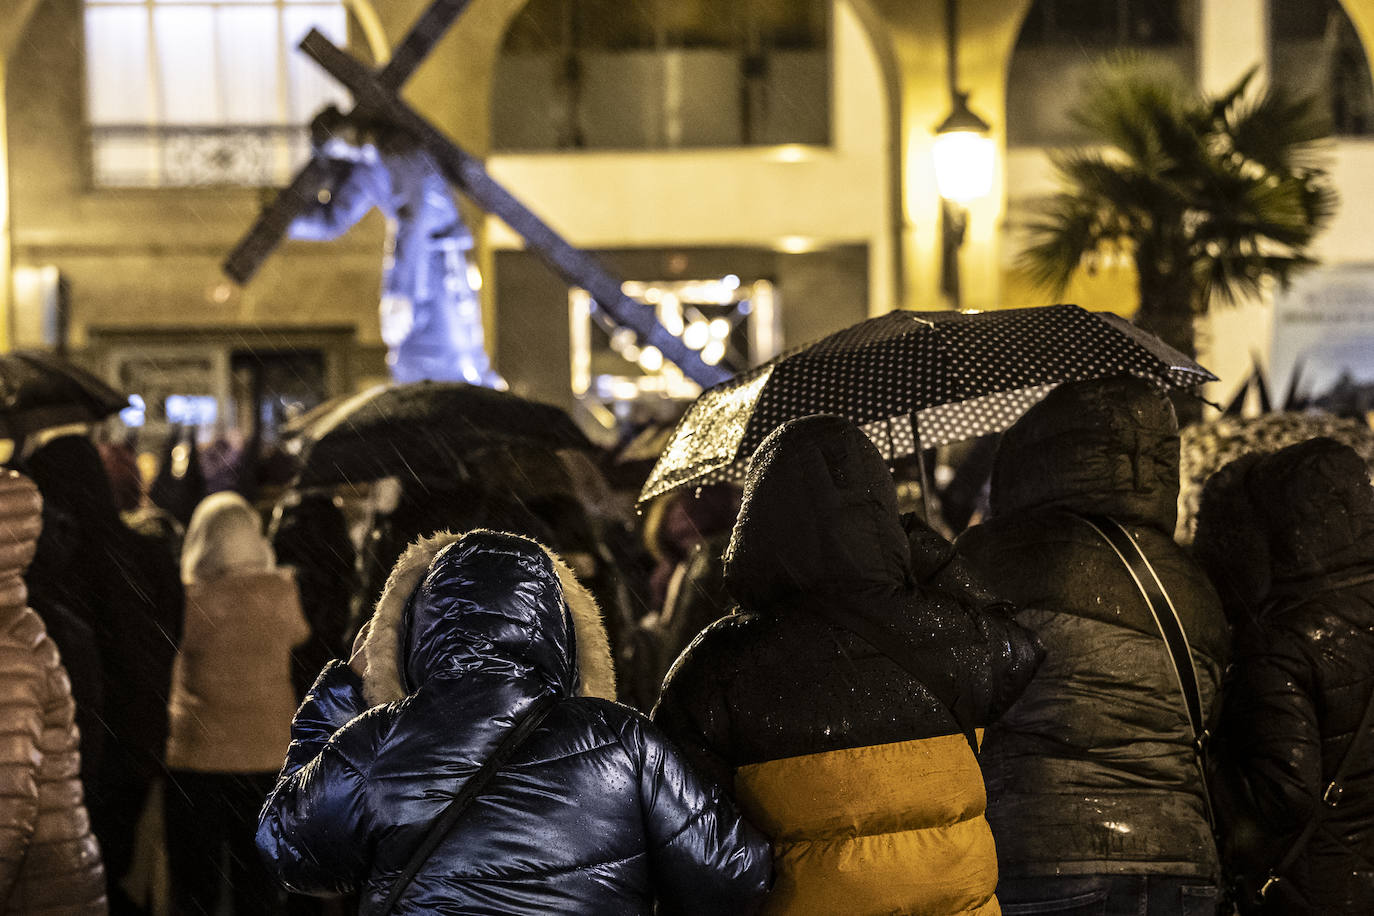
164 490 309 916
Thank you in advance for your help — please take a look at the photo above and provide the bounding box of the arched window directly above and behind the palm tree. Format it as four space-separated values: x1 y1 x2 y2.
1007 0 1198 146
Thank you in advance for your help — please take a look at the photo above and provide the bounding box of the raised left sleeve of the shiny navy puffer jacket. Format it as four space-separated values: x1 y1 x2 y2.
257 661 381 894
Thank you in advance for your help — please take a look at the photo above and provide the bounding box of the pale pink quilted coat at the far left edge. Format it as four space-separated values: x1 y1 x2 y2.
0 471 106 913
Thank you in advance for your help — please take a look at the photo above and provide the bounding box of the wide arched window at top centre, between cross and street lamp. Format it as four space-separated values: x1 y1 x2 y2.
492 0 830 150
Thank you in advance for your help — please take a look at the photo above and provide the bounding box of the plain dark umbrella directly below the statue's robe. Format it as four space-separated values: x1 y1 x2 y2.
293 382 594 488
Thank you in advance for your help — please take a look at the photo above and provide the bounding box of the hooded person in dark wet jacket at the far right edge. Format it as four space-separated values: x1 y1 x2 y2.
1194 438 1374 913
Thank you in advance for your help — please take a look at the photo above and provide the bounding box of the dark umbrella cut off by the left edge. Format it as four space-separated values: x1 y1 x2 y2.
0 350 129 439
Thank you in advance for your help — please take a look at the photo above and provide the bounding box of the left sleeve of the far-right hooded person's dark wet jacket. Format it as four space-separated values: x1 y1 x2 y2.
1223 633 1322 835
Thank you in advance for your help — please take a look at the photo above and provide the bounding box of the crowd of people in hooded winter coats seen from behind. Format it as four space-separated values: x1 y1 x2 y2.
0 378 1374 916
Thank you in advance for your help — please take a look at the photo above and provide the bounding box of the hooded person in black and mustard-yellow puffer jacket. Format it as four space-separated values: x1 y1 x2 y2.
654 416 1037 915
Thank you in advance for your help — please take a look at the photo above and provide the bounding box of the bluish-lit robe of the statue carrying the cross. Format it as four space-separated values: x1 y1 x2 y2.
289 139 506 387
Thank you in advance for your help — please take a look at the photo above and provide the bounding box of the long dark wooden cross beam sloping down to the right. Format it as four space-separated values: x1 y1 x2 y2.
301 29 734 387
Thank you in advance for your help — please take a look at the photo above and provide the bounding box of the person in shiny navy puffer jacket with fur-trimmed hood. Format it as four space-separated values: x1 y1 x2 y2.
257 530 769 915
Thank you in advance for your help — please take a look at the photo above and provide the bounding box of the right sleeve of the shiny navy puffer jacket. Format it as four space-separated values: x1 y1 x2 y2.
621 720 772 915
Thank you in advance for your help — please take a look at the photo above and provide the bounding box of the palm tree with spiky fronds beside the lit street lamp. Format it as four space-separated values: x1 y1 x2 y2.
1020 58 1337 365
